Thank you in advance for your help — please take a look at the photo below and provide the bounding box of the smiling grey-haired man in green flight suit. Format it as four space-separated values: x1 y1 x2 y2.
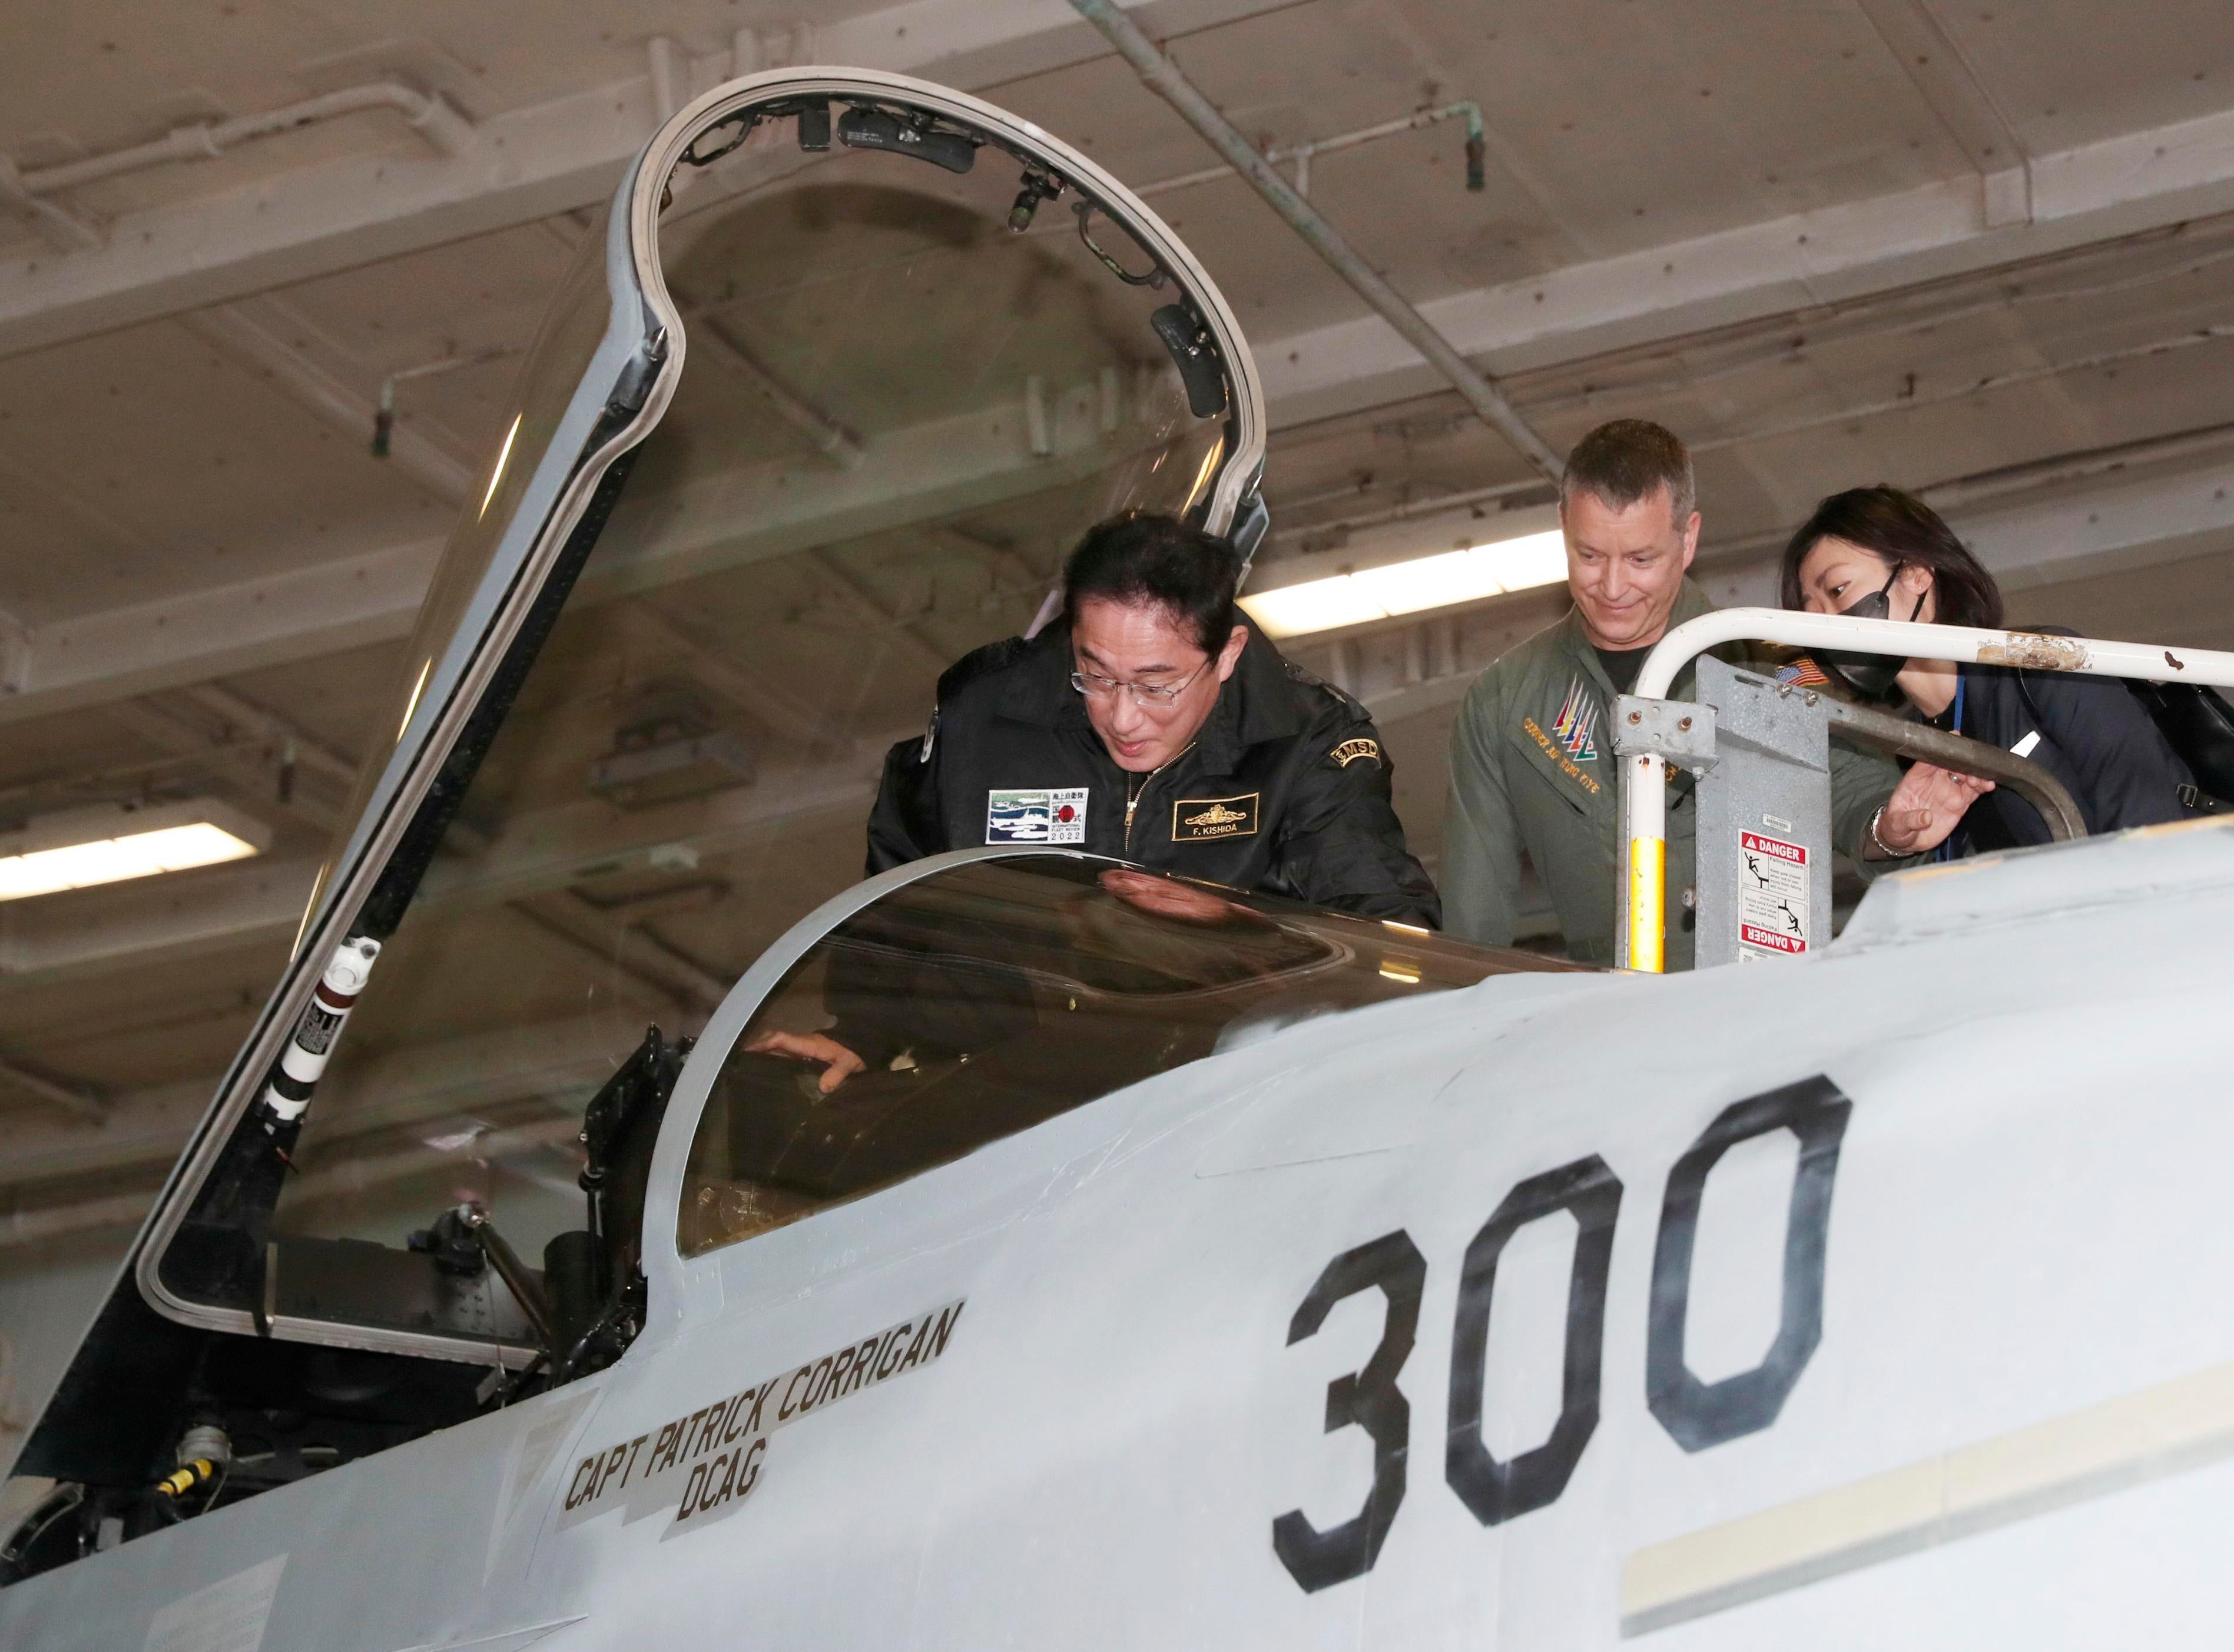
1438 420 1975 969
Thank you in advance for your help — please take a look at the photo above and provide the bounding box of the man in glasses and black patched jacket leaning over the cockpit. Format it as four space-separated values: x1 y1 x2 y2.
869 516 1443 927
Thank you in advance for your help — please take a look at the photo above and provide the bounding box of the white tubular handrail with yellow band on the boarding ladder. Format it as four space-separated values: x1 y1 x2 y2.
1622 607 2234 973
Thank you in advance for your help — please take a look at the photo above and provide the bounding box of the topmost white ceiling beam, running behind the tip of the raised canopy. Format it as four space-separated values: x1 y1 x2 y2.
0 0 1294 355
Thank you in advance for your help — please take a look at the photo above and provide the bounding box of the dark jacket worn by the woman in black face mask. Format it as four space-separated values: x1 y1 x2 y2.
1933 665 2194 855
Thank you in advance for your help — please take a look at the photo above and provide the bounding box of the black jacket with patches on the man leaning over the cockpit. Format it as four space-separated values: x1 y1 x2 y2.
869 625 1443 927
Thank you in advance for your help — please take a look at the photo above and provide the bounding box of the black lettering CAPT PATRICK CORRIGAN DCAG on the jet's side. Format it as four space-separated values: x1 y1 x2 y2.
561 1299 963 1538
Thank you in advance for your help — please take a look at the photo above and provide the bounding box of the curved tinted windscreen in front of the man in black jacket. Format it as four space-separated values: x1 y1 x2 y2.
675 853 1534 1257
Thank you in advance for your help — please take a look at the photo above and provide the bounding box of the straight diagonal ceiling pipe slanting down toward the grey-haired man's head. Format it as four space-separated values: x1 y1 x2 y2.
1070 0 1564 482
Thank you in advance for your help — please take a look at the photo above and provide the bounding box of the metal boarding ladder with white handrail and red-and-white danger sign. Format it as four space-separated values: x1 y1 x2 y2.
1613 607 2234 973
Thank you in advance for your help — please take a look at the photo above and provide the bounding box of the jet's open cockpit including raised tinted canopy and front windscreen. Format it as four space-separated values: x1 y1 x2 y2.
0 69 1544 1574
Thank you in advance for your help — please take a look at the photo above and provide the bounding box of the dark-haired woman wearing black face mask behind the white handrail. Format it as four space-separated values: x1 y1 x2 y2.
1783 487 2194 855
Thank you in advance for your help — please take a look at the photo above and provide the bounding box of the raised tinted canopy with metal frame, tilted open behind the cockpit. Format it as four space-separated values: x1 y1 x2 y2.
22 69 1264 1475
